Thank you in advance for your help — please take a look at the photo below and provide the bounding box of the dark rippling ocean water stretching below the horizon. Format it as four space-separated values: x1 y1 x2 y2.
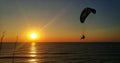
0 42 120 63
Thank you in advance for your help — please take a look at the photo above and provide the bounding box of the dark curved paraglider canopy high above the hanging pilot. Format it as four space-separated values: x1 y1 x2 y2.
80 7 96 23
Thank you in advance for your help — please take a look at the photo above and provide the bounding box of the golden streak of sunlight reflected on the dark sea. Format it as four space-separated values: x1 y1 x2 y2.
28 42 38 63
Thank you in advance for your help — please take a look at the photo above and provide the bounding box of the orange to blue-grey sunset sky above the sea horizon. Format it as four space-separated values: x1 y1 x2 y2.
0 0 120 42
